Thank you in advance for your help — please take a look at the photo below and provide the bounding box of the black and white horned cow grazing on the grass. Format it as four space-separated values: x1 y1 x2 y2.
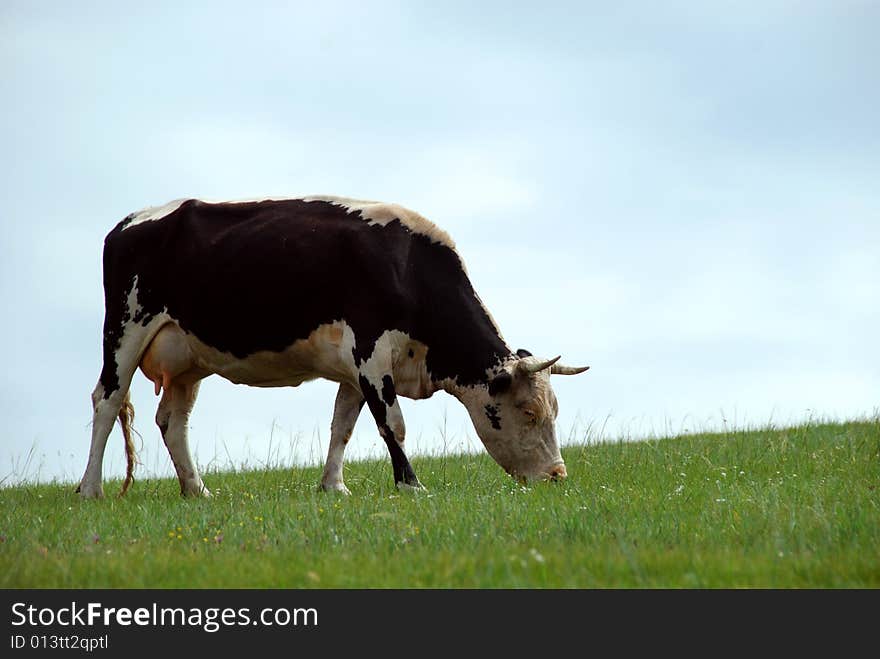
77 196 589 498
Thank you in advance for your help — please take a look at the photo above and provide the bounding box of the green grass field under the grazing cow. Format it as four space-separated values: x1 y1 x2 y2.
0 419 880 588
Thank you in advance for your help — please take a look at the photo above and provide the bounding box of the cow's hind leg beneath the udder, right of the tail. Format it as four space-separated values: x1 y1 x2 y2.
156 379 211 496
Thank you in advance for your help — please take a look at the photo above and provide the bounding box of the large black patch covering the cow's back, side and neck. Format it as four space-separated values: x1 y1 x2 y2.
101 199 510 396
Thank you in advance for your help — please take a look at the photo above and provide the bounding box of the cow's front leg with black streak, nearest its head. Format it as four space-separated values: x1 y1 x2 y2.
359 374 425 490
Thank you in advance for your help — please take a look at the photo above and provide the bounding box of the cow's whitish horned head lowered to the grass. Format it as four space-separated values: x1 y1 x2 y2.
467 350 589 480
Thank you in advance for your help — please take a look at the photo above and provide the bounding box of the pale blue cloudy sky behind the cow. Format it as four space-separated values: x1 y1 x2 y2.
0 0 880 488
